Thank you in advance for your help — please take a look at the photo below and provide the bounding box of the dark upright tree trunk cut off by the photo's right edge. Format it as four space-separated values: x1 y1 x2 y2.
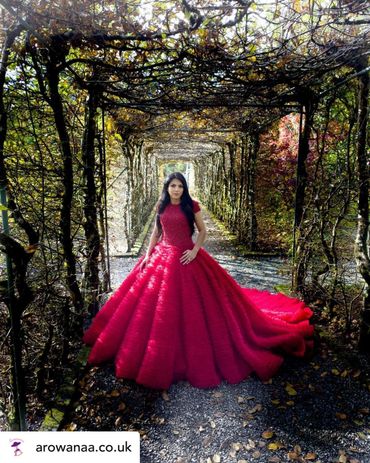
354 59 370 352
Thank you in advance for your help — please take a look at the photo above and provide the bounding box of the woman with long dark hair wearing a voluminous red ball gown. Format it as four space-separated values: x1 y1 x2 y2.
84 172 313 389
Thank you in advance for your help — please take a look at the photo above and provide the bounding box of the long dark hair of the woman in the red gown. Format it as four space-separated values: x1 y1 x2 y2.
156 172 195 236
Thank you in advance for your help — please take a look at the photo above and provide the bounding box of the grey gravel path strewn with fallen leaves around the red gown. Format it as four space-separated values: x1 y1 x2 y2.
63 207 370 463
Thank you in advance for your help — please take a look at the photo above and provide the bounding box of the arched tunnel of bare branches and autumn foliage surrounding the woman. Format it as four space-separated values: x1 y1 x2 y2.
0 0 370 428
